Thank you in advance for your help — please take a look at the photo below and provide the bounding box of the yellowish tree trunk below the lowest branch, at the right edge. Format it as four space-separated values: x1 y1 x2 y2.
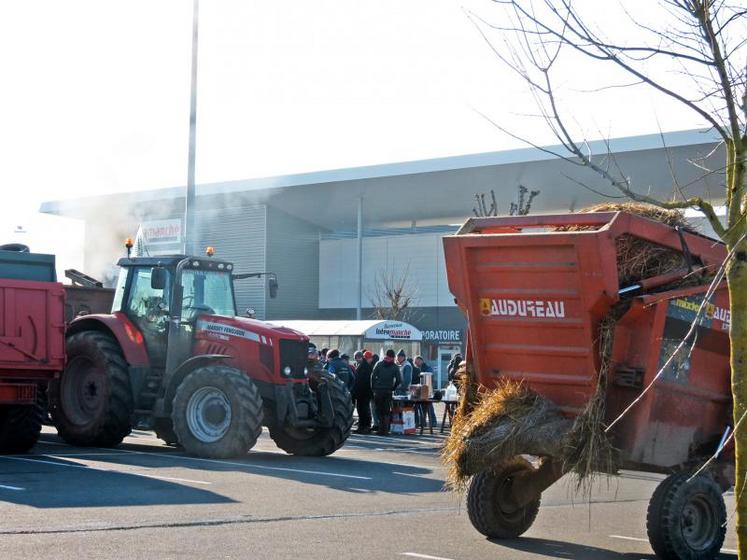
728 241 747 559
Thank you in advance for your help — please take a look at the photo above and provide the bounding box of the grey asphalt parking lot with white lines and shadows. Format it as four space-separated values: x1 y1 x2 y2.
0 429 736 560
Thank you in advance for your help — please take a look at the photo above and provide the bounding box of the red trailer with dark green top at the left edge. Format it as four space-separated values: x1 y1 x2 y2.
0 250 65 453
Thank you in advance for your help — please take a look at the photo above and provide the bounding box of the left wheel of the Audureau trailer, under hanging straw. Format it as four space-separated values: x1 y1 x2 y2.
467 458 540 539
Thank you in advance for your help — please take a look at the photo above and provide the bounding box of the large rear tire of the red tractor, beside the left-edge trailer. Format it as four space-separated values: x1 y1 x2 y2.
49 331 133 447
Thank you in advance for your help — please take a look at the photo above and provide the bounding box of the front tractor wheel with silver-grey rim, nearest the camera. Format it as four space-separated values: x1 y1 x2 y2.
171 365 262 459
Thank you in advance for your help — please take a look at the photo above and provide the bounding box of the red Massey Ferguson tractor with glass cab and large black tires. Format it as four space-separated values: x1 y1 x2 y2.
49 255 353 458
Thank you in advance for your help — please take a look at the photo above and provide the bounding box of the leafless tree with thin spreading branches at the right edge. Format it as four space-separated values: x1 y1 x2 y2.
469 0 747 559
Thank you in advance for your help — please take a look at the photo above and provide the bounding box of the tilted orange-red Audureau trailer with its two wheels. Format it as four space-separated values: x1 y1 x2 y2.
444 212 733 558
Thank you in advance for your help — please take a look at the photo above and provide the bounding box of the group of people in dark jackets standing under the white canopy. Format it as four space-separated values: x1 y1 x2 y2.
309 347 437 435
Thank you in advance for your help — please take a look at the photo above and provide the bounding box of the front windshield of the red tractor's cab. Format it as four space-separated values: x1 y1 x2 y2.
182 270 236 320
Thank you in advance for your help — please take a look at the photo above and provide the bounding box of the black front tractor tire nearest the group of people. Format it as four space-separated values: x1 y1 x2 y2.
270 381 353 457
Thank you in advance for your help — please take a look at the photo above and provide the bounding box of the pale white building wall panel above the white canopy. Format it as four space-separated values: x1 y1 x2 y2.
319 233 454 309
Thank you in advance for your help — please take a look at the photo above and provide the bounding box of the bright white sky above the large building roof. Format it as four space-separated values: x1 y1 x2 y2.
0 0 703 264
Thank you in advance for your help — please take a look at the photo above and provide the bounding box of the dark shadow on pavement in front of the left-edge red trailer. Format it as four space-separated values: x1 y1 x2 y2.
0 454 234 509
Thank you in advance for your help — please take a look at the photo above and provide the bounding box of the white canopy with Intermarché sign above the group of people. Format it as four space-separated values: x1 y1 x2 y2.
270 319 423 341
